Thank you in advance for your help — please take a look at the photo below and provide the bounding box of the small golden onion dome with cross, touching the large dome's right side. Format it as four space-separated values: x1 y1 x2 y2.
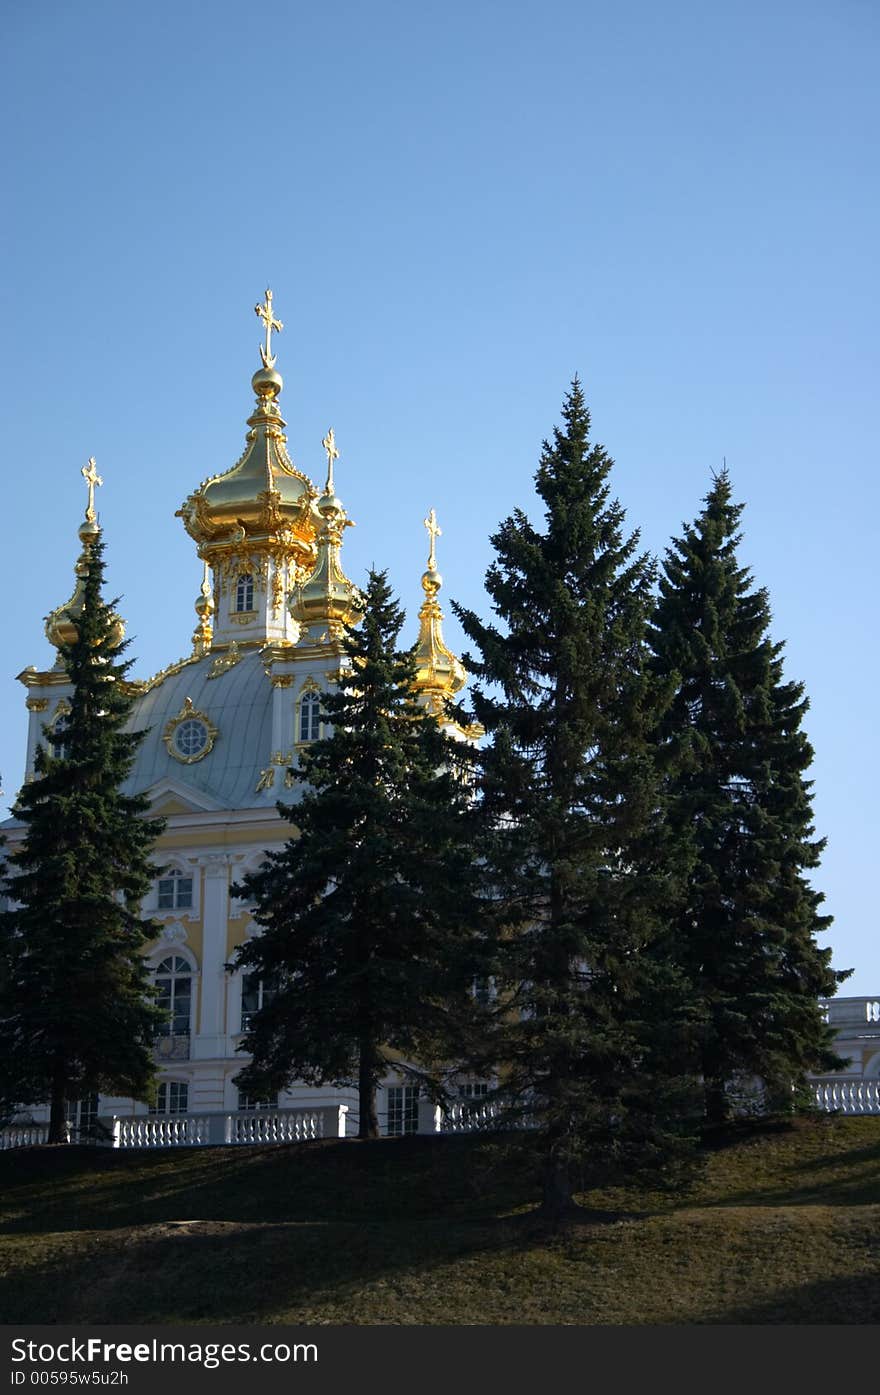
290 427 361 639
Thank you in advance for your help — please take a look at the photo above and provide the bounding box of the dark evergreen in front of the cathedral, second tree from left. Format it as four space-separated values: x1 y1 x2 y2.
237 572 480 1138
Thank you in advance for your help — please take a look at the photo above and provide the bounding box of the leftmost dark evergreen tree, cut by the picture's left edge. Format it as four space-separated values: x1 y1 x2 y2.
0 533 163 1143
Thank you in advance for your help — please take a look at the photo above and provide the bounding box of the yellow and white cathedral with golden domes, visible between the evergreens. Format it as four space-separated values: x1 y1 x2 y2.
6 292 480 1143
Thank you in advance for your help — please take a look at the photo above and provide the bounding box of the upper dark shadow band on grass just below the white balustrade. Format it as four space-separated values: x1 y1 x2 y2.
0 1137 534 1235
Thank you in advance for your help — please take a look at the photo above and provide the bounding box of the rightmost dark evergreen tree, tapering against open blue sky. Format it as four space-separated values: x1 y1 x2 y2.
650 472 847 1122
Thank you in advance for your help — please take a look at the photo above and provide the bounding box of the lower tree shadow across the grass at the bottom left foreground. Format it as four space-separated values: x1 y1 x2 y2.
0 1219 546 1324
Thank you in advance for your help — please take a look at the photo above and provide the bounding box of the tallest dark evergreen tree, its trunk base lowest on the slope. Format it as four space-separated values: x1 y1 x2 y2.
456 379 694 1216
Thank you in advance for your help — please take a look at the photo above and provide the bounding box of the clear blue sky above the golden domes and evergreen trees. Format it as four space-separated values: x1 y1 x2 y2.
0 0 880 993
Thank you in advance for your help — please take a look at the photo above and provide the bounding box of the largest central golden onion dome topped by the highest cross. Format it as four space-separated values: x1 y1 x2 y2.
177 290 318 566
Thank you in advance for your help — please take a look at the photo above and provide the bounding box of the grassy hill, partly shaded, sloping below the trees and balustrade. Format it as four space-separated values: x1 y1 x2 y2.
0 1116 880 1324
